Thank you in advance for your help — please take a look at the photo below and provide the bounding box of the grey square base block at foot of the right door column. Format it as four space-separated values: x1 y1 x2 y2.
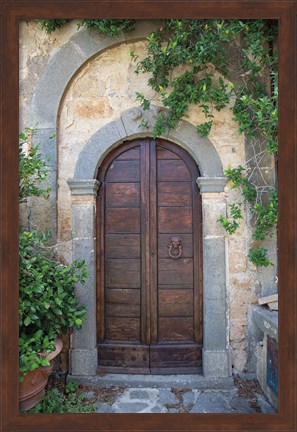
202 348 232 378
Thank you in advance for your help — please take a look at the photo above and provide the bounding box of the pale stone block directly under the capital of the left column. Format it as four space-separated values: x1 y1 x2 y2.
72 204 96 238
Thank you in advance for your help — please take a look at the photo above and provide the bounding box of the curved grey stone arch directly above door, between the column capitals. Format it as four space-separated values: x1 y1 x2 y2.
74 105 224 179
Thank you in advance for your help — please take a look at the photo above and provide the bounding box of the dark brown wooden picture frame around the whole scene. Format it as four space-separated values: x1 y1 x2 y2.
1 0 297 432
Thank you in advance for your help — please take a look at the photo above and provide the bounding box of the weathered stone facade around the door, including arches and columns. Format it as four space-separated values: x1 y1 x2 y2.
20 18 276 376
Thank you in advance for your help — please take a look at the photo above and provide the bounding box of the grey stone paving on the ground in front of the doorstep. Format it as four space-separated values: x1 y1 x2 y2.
82 387 275 414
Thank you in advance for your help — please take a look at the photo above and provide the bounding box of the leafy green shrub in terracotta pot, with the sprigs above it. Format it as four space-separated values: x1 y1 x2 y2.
19 129 87 410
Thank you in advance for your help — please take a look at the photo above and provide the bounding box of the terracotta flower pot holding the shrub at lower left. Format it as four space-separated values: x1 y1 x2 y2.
19 339 63 410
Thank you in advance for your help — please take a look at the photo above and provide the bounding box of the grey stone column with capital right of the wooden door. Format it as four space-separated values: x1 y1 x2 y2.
197 177 231 378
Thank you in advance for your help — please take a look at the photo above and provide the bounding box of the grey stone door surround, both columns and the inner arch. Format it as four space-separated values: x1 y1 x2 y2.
68 106 231 378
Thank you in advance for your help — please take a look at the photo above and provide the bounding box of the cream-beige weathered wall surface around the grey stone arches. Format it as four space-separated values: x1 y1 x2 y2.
20 18 275 371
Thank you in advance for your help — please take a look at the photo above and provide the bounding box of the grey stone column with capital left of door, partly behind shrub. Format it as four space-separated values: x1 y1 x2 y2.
67 180 100 375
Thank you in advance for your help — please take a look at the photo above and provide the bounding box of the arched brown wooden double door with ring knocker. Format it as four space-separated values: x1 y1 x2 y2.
97 139 202 374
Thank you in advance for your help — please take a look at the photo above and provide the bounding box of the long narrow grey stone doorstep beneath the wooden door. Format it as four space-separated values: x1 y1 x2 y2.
66 374 235 390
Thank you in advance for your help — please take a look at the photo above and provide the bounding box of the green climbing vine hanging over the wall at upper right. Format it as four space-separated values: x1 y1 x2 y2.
37 19 278 266
